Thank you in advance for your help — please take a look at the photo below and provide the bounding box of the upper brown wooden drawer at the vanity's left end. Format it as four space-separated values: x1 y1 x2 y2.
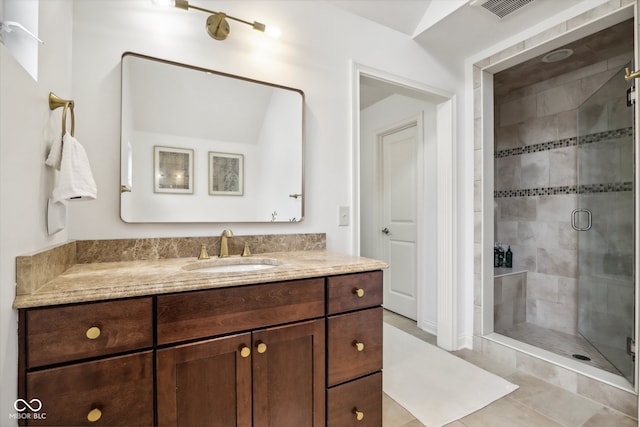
26 298 153 368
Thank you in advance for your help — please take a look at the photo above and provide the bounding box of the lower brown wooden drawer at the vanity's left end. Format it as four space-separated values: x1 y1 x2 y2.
26 351 153 426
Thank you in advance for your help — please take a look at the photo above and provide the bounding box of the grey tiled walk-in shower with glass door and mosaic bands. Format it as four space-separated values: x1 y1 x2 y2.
494 20 635 383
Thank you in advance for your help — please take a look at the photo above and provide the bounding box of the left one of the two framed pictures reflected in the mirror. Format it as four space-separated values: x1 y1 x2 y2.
153 145 193 194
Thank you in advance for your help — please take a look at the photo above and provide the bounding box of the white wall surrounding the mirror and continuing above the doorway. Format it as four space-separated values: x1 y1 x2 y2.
70 0 462 252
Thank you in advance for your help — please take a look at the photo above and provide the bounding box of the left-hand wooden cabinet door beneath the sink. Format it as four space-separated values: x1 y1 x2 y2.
157 333 252 427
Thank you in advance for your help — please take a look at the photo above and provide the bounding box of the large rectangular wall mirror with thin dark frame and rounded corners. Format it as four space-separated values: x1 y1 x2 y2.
120 52 304 223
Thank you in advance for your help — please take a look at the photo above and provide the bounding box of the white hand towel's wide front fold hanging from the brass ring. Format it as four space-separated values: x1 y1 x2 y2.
52 133 98 202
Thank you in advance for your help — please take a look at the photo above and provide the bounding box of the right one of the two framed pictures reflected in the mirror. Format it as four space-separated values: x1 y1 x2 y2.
209 151 244 196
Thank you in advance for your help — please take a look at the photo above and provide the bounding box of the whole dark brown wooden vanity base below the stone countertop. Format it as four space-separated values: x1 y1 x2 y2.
13 246 383 427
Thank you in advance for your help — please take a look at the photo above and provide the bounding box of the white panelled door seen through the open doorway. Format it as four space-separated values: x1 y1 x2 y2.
380 123 419 320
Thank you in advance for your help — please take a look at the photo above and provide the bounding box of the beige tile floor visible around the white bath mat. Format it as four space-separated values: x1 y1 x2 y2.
383 311 638 427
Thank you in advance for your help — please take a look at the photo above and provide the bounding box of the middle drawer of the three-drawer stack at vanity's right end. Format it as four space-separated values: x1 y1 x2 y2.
327 307 382 386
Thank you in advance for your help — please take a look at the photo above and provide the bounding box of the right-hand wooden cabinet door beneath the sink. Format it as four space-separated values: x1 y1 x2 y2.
253 320 325 427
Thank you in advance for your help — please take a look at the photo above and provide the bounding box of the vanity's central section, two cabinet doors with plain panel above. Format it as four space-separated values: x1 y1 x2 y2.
157 278 325 427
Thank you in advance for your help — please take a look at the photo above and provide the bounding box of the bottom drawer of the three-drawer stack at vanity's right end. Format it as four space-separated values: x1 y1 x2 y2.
327 372 382 427
